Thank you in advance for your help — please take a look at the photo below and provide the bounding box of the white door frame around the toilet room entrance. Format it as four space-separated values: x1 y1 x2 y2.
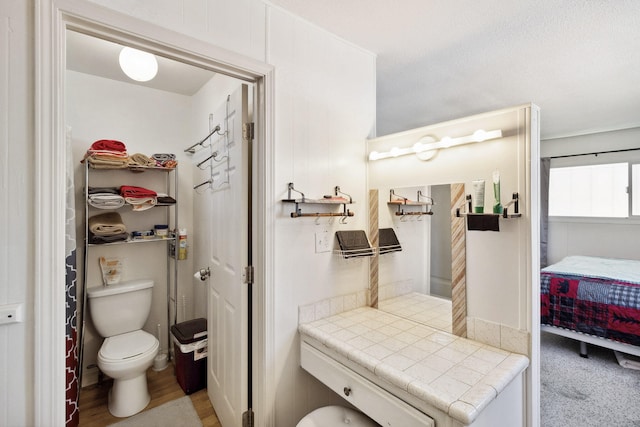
32 0 275 426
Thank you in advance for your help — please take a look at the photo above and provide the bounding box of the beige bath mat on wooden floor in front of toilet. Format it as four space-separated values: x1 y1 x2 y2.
110 396 202 427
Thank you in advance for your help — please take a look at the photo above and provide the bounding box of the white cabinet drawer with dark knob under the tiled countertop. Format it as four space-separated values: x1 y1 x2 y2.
300 342 435 427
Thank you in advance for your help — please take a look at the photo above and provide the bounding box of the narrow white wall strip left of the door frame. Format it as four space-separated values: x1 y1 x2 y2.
0 0 33 426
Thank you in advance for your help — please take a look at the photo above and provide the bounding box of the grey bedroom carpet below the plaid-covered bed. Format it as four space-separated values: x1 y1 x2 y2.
540 332 640 427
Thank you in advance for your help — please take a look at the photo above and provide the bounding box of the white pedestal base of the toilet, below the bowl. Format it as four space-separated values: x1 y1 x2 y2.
109 371 151 418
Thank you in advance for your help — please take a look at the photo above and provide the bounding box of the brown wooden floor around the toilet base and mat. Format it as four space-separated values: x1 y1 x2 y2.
80 364 221 427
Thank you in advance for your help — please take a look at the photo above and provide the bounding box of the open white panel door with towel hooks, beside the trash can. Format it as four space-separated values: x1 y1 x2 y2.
205 85 250 427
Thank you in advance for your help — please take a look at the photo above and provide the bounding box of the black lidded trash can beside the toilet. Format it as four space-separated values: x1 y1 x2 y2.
171 318 207 394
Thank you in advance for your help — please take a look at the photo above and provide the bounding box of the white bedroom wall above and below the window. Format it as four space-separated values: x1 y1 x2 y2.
541 128 640 264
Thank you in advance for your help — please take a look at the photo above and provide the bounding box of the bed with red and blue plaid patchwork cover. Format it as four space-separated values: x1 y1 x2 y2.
540 256 640 357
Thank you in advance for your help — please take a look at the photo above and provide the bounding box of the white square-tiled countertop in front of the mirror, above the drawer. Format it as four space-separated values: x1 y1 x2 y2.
298 307 529 424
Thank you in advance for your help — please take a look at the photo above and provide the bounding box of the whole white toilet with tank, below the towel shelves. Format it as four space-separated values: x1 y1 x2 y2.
87 280 159 417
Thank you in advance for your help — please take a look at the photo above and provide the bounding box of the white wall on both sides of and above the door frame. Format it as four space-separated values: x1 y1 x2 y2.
0 0 375 427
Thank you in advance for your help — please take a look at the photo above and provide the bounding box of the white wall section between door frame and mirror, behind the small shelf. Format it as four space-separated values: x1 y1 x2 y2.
268 9 375 427
